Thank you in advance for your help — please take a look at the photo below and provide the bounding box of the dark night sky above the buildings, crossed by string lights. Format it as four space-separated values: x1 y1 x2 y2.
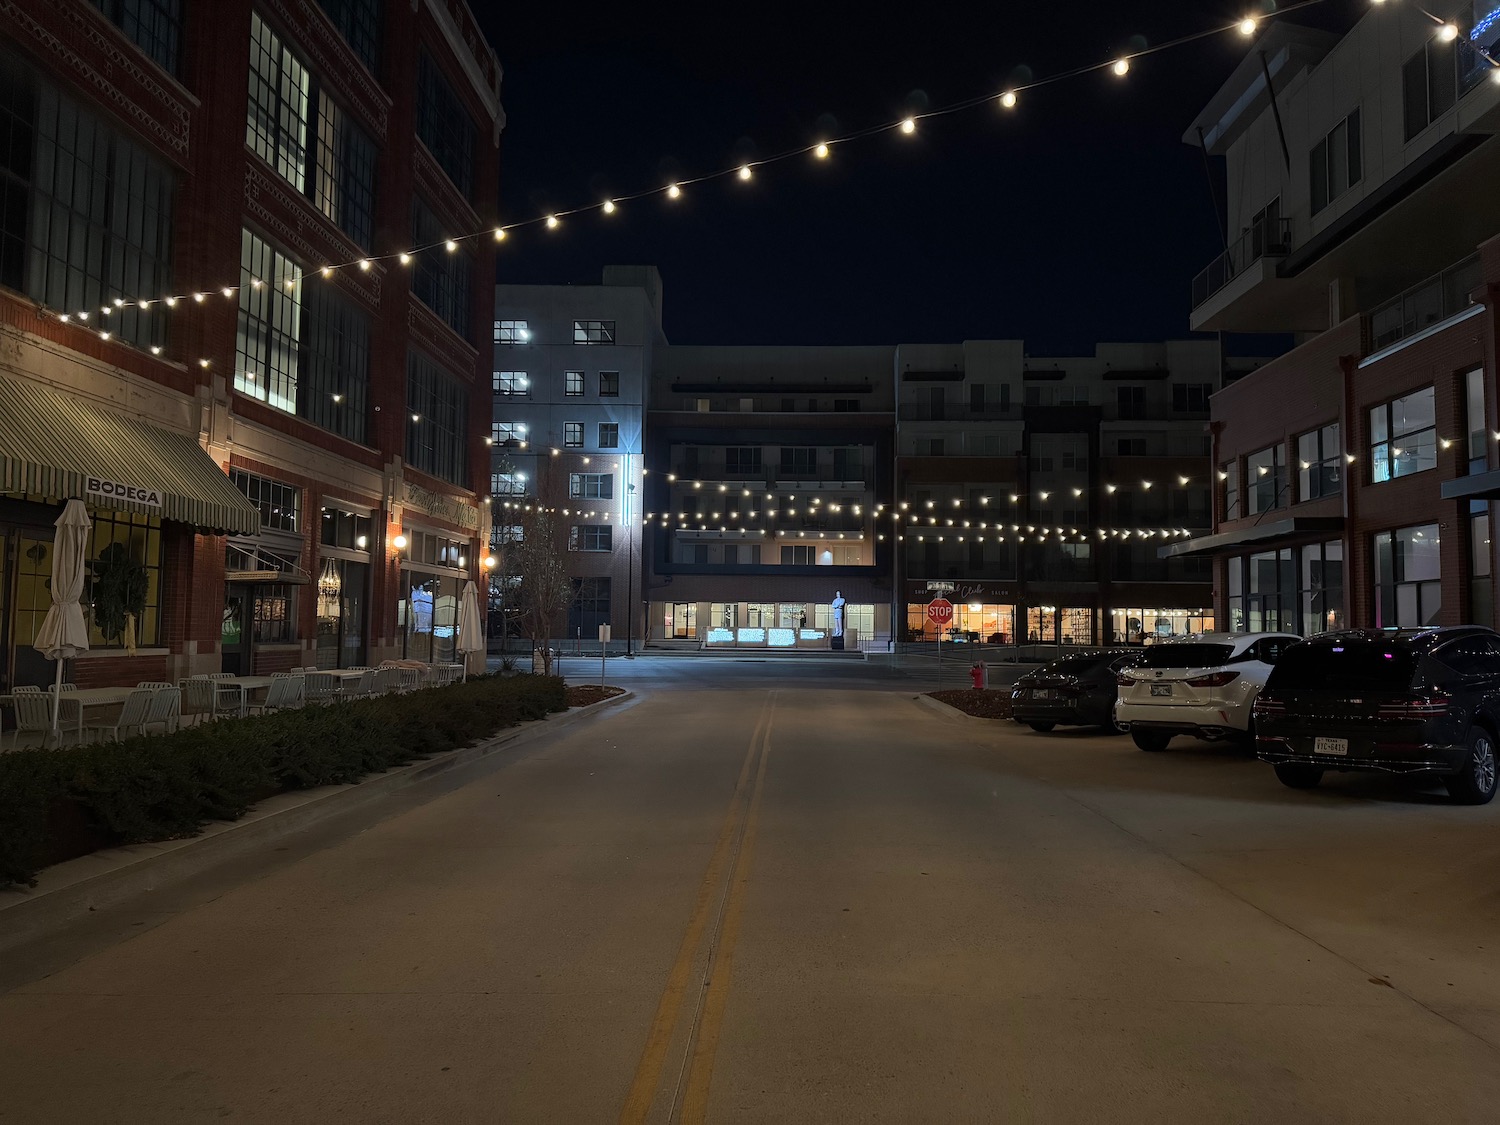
474 0 1365 354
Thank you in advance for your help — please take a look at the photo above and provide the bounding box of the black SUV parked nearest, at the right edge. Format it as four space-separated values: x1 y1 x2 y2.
1254 626 1500 804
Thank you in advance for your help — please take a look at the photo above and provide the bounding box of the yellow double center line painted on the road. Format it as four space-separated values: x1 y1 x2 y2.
620 692 776 1125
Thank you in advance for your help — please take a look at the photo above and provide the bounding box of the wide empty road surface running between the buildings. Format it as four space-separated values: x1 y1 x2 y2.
0 659 1500 1125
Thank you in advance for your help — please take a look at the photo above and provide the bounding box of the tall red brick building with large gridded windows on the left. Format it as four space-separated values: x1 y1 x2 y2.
0 0 504 686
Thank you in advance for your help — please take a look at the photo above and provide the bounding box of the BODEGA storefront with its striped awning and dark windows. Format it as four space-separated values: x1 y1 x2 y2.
0 380 260 687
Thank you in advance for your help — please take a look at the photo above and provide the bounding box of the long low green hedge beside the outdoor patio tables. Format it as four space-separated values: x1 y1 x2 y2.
0 675 567 887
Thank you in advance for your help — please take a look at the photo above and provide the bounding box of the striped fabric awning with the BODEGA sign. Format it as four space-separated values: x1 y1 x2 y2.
0 380 261 536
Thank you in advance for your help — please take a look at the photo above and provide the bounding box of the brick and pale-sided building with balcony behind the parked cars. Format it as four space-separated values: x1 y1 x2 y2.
1163 0 1500 633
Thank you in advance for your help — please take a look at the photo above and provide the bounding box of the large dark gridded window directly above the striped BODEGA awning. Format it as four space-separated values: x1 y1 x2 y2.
0 51 174 347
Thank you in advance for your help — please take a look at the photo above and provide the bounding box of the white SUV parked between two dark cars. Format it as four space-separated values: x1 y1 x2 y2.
1115 633 1301 750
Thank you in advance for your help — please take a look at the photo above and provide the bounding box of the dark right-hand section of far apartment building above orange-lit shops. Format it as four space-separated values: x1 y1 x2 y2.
896 341 1260 645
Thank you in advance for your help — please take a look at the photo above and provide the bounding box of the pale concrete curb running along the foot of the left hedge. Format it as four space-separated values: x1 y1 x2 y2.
0 690 635 951
